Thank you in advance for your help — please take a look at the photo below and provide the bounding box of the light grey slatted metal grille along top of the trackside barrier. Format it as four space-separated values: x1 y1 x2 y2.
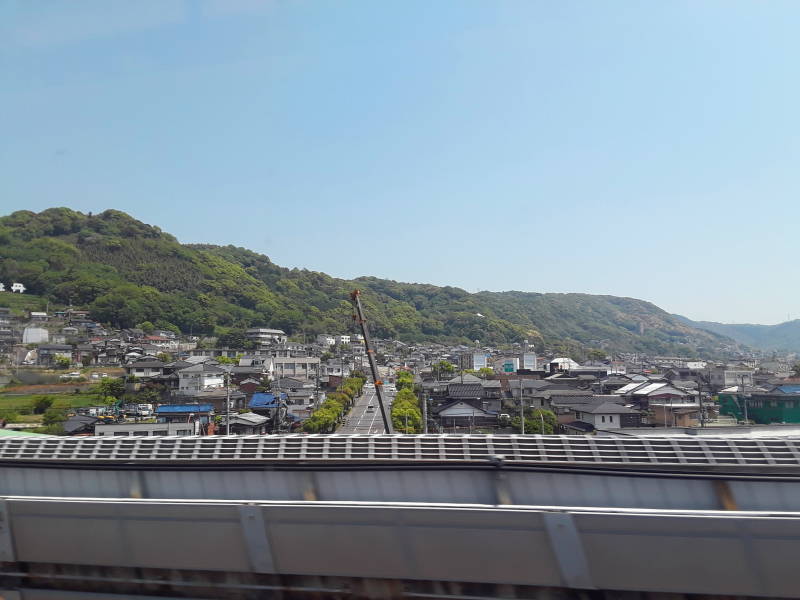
0 434 800 471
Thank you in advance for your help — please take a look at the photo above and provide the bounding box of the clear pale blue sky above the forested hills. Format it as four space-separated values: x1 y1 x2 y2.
0 0 800 323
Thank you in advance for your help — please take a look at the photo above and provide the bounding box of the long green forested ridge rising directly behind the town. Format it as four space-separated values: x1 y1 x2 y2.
0 208 733 356
